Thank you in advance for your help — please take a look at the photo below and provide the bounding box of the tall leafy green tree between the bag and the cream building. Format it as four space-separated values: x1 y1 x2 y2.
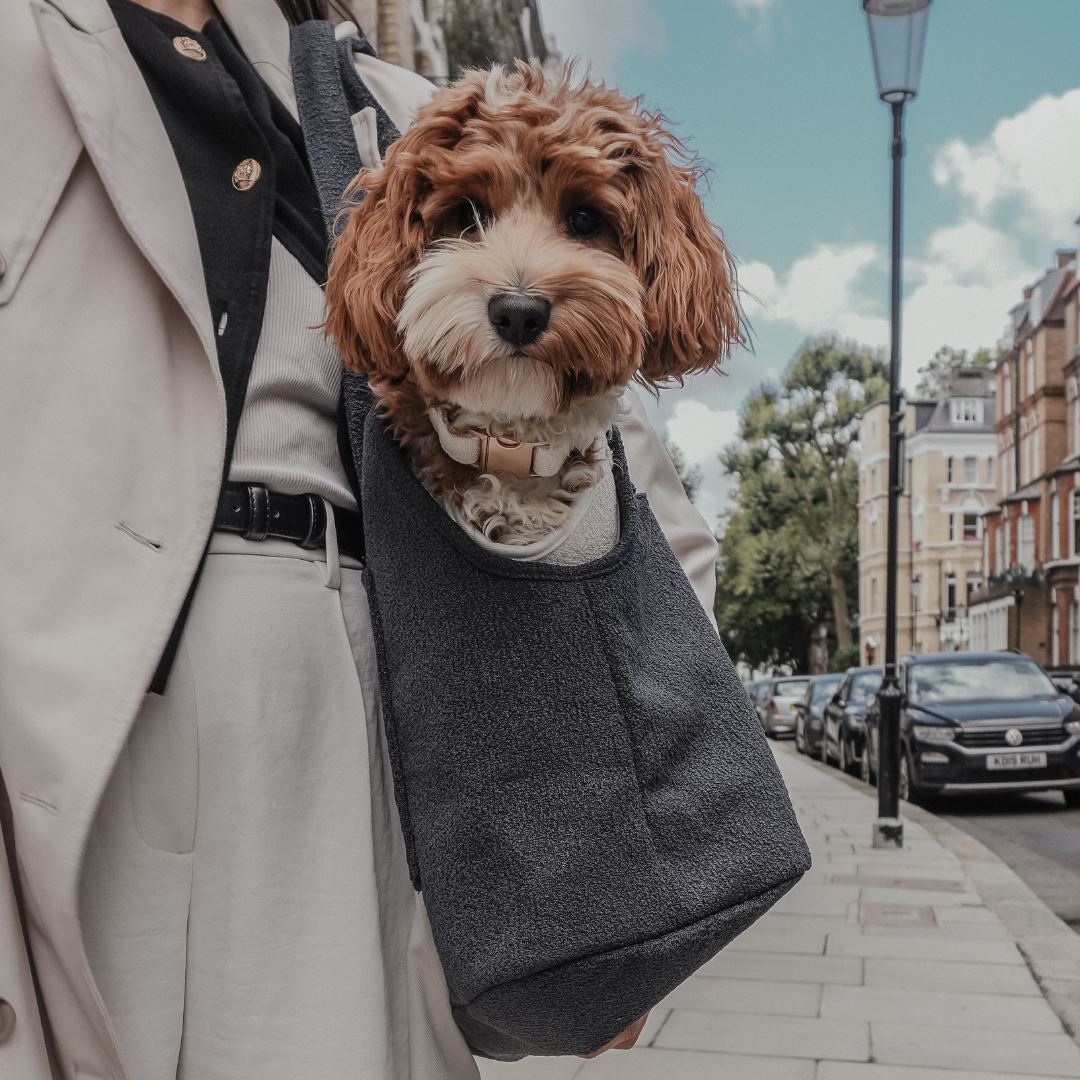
716 336 888 667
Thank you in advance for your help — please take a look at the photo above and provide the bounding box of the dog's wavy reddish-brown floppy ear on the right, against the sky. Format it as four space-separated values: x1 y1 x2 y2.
624 137 743 386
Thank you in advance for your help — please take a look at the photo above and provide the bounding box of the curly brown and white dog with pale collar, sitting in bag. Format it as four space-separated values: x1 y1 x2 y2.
326 62 742 561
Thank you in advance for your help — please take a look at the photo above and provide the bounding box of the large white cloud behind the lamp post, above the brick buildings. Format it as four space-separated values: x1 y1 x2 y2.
740 90 1080 388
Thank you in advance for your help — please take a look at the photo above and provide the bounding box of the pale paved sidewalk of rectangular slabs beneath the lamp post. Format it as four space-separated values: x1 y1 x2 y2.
480 744 1080 1080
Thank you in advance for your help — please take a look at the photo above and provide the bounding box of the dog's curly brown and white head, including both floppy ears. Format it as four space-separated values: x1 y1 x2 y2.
327 65 740 428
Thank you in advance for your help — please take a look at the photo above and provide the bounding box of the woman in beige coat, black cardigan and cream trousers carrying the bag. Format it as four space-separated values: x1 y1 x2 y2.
0 0 716 1080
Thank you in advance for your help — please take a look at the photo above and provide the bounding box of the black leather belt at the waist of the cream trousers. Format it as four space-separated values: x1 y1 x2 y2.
214 484 364 563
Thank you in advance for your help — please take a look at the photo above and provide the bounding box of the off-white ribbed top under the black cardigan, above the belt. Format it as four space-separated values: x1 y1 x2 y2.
229 238 356 510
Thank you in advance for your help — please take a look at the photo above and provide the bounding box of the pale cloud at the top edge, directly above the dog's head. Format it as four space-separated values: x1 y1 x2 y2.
541 0 666 83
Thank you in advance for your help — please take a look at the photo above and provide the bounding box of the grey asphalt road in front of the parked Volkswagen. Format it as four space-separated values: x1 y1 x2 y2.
937 792 1080 933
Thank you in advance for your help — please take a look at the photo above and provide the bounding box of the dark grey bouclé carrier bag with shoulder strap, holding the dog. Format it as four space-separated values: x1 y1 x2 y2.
293 23 810 1061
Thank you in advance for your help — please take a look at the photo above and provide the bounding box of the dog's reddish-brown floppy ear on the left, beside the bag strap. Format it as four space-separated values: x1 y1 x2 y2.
326 157 424 382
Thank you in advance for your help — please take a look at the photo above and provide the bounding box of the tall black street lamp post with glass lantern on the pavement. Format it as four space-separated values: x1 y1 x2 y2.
863 0 930 848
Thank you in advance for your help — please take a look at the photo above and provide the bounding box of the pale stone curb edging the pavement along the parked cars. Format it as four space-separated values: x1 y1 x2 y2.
777 743 1080 1043
